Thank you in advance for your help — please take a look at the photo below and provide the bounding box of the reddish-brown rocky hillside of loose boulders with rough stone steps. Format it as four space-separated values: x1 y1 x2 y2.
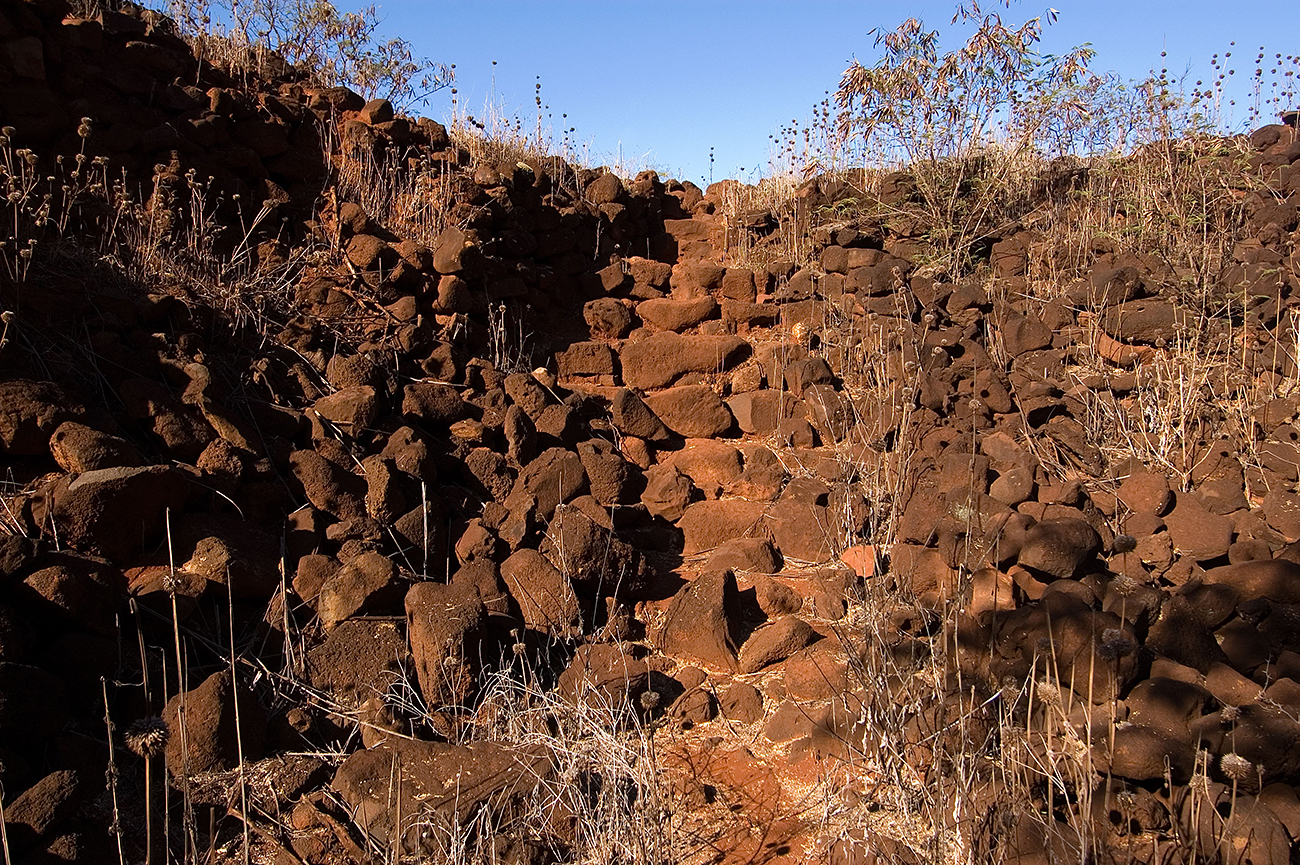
0 0 1300 865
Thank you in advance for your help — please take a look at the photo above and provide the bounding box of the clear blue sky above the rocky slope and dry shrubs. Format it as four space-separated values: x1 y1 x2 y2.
377 0 1300 182
